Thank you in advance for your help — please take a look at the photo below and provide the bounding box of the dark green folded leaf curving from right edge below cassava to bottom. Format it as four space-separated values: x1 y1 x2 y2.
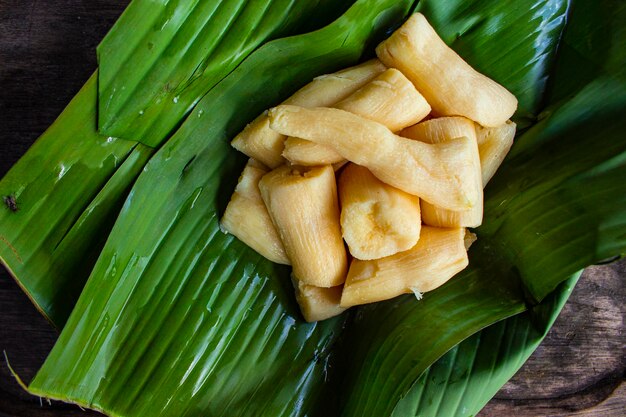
334 75 626 416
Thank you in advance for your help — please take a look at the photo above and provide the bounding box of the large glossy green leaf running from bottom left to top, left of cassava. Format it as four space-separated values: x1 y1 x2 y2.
30 0 420 416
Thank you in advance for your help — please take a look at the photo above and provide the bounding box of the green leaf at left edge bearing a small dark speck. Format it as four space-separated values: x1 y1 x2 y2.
0 74 153 327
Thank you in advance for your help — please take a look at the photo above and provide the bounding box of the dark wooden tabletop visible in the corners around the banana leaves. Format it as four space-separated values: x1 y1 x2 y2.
0 0 626 417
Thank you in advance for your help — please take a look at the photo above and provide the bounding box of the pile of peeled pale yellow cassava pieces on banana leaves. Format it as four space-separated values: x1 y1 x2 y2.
222 14 517 321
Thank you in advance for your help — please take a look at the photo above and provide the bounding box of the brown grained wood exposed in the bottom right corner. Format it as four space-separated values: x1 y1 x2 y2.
479 259 626 417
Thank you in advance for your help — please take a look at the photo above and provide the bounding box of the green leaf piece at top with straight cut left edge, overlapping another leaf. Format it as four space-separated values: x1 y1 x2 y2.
98 0 351 147
